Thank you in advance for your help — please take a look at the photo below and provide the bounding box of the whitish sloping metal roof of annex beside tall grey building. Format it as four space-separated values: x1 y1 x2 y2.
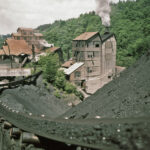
64 62 84 75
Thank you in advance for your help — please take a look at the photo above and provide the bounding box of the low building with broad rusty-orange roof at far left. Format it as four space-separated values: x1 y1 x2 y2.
0 38 40 68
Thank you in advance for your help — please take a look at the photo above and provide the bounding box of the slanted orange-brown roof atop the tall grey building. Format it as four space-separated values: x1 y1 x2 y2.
74 32 99 41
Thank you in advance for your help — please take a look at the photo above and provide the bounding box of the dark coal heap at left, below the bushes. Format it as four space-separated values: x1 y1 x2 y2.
0 77 70 118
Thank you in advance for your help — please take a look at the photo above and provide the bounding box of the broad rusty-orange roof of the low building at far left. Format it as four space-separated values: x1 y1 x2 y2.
3 39 32 56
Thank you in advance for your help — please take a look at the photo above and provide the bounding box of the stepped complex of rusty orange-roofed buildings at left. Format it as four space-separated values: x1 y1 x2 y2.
0 28 63 68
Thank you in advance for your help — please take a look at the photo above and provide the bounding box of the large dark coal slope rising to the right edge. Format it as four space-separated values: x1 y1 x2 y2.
63 52 150 119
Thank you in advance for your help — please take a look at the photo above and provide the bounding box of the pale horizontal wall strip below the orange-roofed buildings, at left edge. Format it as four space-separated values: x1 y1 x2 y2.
0 68 31 77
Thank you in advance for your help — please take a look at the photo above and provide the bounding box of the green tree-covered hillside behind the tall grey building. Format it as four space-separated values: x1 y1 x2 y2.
38 0 150 66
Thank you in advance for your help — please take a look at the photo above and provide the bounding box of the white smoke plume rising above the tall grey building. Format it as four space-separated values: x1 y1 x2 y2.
96 0 111 27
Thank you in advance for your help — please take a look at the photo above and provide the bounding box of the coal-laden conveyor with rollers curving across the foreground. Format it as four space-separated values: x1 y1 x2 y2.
0 73 150 150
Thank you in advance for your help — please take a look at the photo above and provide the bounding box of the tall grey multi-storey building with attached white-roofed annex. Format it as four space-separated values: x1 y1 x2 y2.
62 32 116 94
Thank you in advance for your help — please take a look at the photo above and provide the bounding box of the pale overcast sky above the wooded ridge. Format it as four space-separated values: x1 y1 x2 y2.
0 0 118 34
